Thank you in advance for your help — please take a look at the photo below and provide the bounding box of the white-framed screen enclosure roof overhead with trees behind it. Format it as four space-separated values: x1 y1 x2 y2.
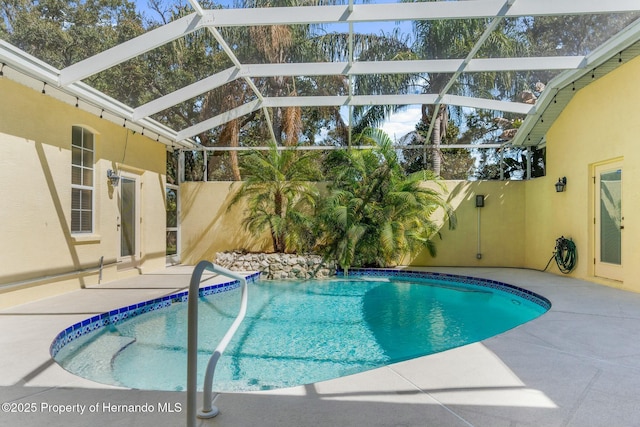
0 0 640 184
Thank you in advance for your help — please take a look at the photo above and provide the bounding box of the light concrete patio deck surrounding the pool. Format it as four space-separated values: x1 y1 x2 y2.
0 267 640 427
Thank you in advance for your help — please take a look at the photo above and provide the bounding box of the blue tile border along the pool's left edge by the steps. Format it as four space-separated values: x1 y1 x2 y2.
49 273 260 358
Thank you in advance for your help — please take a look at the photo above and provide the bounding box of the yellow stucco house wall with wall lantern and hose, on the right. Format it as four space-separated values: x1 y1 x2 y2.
525 53 640 292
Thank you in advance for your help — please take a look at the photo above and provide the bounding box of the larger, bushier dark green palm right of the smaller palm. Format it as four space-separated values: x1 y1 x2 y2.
320 128 455 271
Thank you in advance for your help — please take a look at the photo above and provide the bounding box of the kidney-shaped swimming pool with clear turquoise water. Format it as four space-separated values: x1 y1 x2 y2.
51 270 550 391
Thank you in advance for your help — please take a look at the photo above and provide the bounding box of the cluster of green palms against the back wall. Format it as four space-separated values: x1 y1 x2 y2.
229 128 455 270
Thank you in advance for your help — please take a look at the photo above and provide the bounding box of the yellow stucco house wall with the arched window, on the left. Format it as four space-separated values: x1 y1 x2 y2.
0 78 166 307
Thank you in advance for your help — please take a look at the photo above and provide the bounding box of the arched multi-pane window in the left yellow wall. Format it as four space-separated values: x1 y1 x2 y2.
71 126 94 233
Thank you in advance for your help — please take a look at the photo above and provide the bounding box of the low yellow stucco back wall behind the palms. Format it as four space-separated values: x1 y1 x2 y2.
180 181 524 267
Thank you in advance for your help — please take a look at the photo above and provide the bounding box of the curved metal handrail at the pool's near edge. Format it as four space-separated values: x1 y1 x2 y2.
187 261 247 427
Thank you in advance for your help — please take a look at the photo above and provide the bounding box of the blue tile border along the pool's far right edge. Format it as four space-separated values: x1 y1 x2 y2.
337 268 551 311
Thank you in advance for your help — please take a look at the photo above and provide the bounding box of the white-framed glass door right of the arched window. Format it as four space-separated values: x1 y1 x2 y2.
118 175 140 267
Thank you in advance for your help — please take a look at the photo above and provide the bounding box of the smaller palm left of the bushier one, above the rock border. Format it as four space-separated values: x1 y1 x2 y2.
229 142 319 253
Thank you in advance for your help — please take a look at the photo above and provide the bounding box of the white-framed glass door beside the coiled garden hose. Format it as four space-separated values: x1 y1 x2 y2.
595 162 624 280
